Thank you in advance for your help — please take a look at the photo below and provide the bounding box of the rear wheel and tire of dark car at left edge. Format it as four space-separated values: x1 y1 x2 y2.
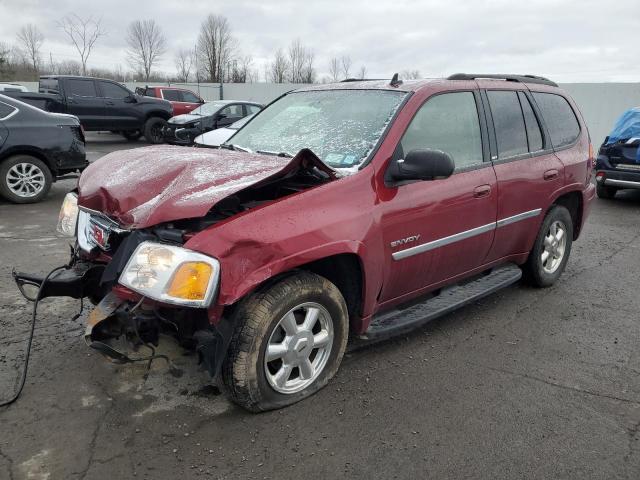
0 155 53 203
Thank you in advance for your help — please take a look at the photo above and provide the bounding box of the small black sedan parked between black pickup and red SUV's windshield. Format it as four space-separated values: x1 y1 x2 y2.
164 100 263 145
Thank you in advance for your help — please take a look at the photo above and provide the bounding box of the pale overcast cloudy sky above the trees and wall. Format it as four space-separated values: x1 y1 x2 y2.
0 0 640 82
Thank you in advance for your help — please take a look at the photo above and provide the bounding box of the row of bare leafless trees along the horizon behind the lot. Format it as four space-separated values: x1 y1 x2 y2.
0 14 420 83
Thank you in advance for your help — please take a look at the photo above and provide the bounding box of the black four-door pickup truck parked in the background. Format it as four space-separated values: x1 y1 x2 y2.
6 75 173 143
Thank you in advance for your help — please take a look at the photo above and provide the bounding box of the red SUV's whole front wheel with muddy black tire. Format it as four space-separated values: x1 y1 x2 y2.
222 272 349 412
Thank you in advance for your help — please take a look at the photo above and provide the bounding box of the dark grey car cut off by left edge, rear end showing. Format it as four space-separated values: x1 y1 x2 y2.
0 95 88 203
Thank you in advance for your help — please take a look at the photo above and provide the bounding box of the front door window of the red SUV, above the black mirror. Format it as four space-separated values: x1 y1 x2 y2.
397 92 483 170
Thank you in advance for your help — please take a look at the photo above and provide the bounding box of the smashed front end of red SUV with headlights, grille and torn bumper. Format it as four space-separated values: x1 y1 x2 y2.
13 193 232 376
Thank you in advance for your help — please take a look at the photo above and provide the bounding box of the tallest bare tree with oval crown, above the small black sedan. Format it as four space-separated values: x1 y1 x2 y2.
197 14 235 82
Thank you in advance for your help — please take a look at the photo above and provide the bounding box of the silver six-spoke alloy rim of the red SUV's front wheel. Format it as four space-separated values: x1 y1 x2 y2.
264 302 334 394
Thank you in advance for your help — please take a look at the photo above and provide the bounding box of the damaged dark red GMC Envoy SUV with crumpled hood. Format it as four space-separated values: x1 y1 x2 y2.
15 74 594 411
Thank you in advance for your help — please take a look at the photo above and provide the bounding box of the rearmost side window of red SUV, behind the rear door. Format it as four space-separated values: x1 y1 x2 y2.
533 92 580 148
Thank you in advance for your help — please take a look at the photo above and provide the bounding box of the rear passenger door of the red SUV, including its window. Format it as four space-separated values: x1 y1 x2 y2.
483 89 564 261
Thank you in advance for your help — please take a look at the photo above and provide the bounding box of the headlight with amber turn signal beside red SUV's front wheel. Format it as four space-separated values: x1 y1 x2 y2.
119 242 220 307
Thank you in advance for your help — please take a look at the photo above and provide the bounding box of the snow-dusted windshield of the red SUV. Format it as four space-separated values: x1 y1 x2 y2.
228 90 406 168
